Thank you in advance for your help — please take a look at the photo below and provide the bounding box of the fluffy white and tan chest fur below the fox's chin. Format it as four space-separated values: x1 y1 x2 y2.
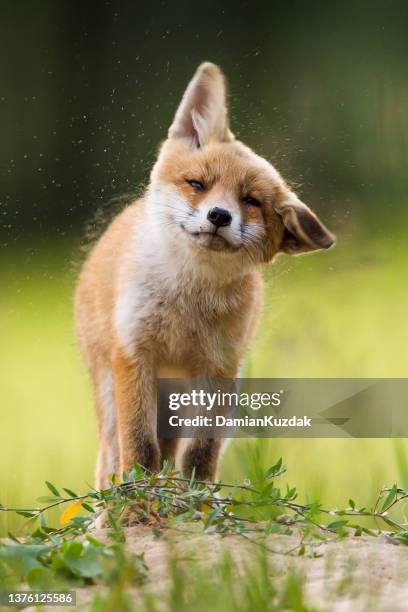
114 218 245 362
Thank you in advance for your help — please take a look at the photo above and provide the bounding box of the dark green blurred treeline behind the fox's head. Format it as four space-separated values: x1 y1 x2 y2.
0 0 408 244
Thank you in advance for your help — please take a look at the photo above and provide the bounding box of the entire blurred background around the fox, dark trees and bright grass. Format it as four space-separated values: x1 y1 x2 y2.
0 0 408 529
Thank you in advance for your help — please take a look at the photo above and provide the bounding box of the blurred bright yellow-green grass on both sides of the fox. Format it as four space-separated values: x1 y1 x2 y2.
0 232 408 529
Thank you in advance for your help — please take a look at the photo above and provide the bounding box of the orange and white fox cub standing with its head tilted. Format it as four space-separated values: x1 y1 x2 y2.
75 62 335 489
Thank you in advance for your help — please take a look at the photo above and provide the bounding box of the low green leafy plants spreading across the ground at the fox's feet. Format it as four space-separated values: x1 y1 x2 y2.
0 459 408 588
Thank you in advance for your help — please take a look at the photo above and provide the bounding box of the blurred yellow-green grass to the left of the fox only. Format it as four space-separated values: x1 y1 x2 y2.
0 251 96 532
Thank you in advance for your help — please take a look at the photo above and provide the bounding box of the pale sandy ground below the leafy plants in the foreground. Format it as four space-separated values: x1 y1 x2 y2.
54 526 408 612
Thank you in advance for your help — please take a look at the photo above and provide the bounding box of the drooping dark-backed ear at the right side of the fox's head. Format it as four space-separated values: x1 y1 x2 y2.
275 195 336 255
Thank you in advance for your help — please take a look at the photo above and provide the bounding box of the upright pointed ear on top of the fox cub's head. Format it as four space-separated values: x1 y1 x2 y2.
169 62 233 147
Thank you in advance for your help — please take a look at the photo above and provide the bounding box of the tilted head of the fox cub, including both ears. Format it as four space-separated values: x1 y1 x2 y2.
149 63 334 265
